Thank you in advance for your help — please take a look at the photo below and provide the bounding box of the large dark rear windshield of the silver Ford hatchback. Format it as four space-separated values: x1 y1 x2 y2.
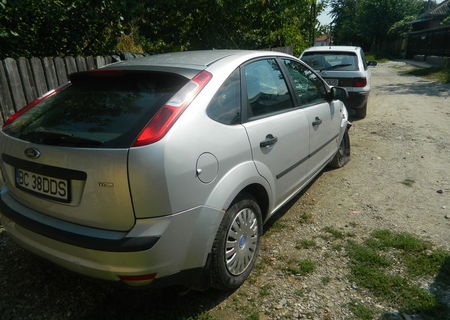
3 71 188 148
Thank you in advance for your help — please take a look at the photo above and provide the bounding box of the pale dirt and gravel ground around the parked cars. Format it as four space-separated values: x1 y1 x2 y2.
0 62 450 320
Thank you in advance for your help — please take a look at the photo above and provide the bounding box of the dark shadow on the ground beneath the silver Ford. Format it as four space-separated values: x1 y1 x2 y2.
0 174 321 320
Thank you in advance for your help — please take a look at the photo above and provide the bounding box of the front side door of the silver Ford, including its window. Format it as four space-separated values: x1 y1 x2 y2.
282 59 343 176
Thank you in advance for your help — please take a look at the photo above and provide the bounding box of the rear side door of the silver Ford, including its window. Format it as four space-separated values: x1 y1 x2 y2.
241 58 309 207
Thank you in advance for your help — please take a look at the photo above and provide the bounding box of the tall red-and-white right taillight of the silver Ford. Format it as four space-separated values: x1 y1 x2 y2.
132 71 212 147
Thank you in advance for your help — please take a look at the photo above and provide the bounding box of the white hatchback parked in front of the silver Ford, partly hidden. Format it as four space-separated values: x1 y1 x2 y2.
300 46 377 119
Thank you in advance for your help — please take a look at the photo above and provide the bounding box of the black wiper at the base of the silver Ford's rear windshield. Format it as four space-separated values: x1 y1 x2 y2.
20 129 103 147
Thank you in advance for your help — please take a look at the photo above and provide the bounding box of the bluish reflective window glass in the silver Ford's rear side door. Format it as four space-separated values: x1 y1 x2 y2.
244 59 294 120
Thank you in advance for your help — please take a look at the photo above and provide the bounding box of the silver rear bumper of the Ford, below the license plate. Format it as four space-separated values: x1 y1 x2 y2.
0 188 223 285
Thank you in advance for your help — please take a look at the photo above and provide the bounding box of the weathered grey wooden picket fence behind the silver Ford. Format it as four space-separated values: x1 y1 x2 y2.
0 53 144 124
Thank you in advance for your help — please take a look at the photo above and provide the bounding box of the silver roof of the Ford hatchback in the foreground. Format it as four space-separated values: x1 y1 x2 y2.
104 50 286 78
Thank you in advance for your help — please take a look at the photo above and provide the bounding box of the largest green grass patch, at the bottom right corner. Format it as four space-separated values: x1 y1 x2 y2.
346 230 450 319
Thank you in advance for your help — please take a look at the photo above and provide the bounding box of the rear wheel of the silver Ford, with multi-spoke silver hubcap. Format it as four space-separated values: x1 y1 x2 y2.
210 194 262 291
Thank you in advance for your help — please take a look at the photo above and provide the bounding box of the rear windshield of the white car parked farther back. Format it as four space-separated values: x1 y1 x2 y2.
302 52 359 71
